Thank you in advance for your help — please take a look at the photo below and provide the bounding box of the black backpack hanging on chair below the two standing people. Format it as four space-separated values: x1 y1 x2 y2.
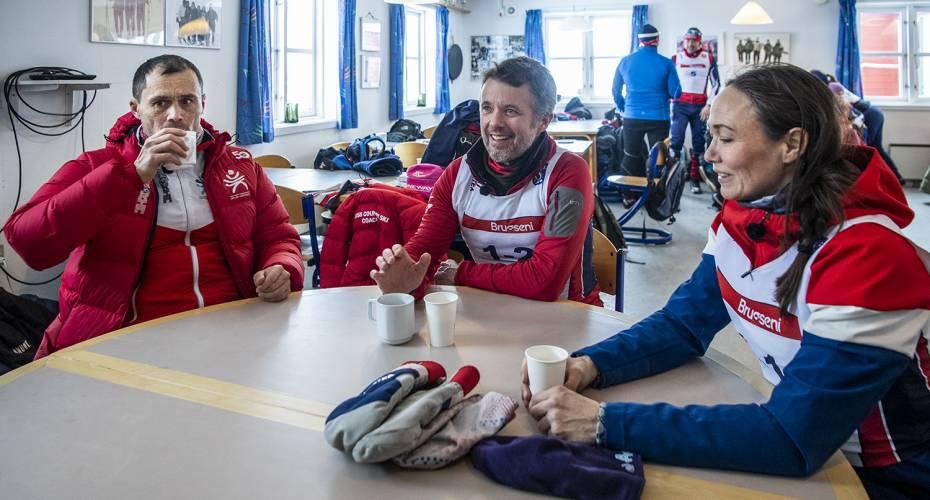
646 142 688 224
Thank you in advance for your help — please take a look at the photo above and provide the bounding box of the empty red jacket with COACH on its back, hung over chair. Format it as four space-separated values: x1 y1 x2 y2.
320 185 426 288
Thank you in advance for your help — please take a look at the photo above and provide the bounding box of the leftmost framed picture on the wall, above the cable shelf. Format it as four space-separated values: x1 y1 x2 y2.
90 0 165 45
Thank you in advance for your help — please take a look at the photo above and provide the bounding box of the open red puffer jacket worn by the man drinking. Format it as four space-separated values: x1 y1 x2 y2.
3 113 303 358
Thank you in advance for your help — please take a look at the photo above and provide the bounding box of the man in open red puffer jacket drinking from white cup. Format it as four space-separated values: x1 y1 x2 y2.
4 55 303 358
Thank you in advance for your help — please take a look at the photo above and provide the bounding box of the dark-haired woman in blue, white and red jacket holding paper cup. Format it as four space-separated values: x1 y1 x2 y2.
523 65 930 498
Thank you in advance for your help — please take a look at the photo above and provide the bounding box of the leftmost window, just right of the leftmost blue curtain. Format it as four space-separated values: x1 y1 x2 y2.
272 0 339 123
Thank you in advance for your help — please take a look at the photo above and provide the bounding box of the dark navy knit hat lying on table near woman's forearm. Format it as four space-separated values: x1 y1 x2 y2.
471 436 646 499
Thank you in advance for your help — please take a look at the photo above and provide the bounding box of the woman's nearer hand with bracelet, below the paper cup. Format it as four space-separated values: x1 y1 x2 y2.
529 385 600 444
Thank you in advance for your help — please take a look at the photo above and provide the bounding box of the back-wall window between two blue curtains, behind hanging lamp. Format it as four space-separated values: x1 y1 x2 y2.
543 11 632 101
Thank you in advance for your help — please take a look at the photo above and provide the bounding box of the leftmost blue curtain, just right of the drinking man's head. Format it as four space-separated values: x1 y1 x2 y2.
236 0 274 144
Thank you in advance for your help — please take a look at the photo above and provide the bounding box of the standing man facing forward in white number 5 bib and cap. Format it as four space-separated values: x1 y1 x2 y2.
669 28 720 194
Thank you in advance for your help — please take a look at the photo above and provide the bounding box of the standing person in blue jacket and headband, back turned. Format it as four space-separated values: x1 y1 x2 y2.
613 24 681 183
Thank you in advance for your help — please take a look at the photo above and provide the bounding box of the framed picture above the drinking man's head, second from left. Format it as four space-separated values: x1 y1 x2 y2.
165 0 223 49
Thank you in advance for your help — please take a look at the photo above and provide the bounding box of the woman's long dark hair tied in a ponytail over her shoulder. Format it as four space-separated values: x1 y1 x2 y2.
729 64 858 313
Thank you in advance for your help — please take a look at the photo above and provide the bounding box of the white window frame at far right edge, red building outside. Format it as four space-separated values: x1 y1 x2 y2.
856 2 930 107
